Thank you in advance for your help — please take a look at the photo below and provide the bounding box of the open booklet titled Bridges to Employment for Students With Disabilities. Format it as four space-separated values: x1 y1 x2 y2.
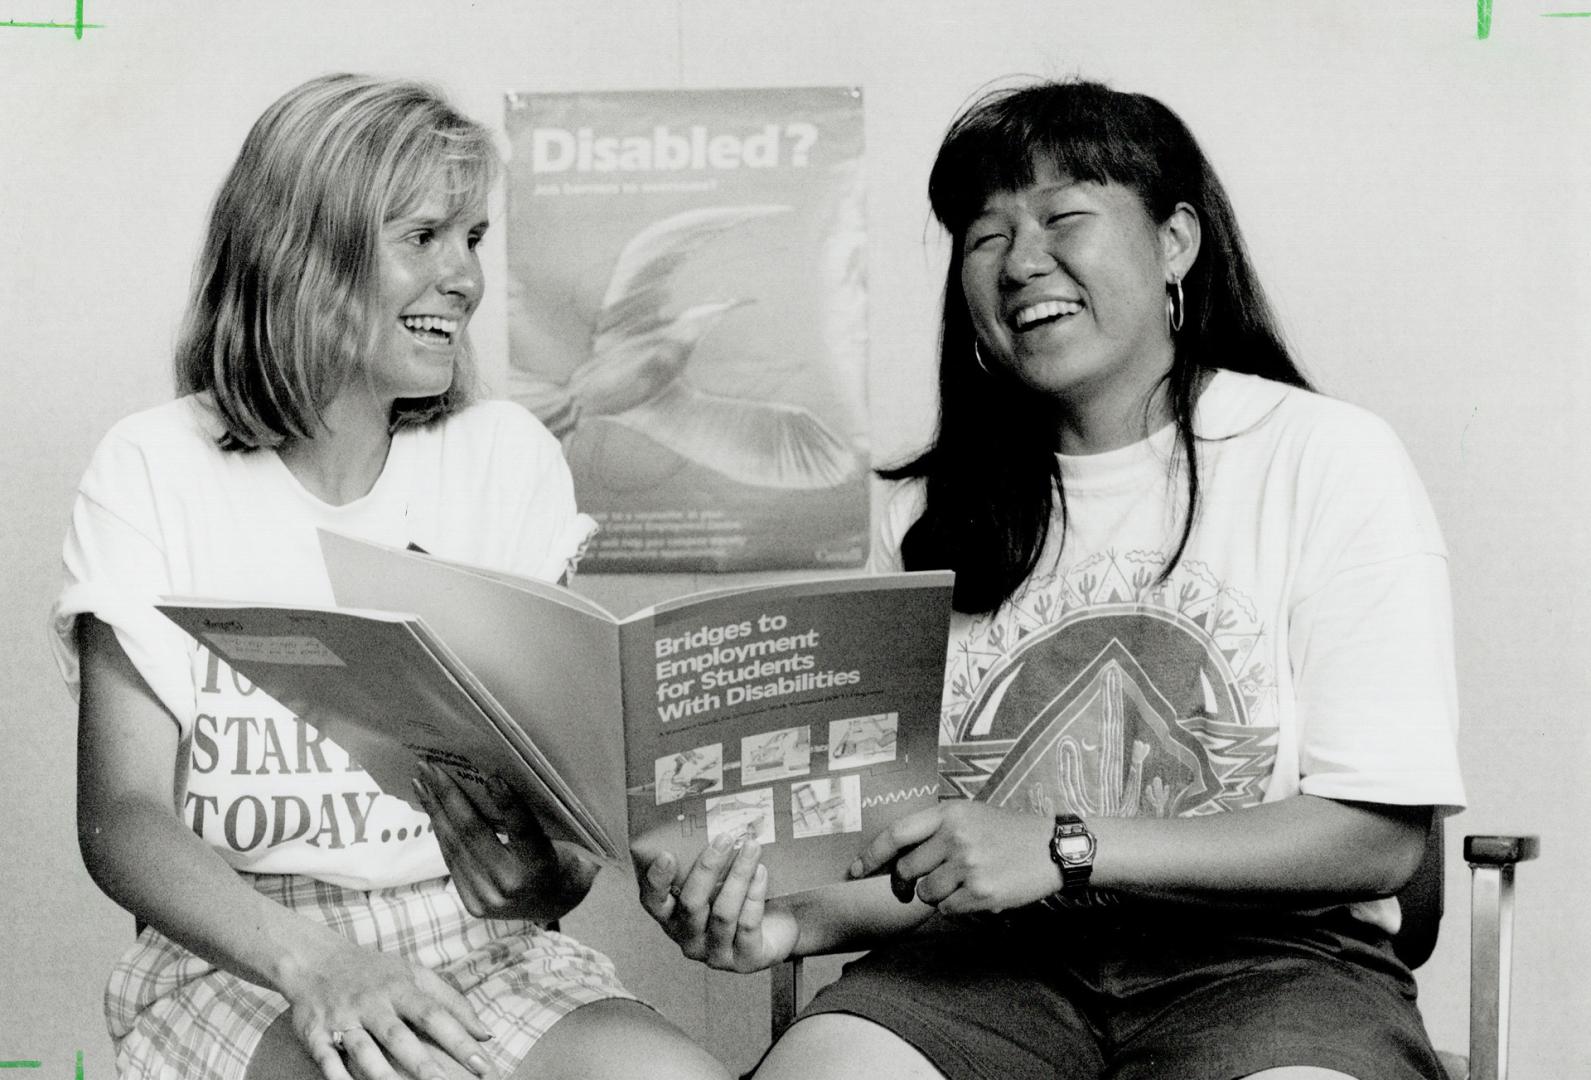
159 531 953 895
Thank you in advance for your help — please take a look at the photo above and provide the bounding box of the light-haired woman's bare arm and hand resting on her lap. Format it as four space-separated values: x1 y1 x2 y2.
78 616 492 1080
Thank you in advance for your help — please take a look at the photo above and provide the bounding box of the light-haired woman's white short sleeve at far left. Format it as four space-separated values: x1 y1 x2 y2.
51 429 194 731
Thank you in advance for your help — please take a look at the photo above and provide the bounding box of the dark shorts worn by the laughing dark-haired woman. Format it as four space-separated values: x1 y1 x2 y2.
802 908 1445 1080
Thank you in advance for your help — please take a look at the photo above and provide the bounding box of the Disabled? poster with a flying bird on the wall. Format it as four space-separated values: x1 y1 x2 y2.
506 87 869 573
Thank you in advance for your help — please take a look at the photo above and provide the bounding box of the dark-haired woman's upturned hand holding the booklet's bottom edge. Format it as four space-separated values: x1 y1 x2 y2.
641 835 797 972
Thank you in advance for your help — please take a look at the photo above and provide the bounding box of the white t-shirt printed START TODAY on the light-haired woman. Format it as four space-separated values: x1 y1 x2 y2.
53 396 595 889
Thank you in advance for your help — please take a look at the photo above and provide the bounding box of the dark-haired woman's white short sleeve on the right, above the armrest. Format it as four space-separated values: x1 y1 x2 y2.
1287 417 1464 810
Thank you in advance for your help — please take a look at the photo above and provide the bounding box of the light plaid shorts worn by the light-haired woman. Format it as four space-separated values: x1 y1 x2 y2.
105 875 632 1080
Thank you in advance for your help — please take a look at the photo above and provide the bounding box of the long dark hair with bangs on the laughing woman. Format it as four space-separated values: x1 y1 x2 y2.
878 81 1309 612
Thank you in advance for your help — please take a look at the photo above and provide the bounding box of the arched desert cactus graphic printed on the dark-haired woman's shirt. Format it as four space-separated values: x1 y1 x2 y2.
940 550 1278 818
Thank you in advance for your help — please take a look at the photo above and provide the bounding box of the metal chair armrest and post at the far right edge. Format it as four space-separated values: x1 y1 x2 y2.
1464 837 1542 1080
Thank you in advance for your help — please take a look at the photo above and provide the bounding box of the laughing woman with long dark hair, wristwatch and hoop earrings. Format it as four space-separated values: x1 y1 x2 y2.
643 83 1464 1080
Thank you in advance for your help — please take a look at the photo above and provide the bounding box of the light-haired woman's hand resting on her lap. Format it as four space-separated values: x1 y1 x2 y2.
278 938 492 1080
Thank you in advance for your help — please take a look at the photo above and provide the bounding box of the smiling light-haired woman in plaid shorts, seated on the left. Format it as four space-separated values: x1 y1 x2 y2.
54 75 724 1080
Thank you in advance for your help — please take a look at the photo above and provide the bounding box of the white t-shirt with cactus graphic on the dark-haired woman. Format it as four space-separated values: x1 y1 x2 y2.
877 371 1464 929
